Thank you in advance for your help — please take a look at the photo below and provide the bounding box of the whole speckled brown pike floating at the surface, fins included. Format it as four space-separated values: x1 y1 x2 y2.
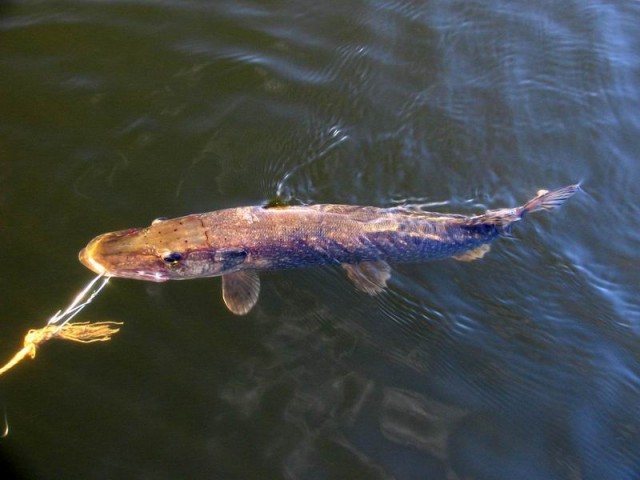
79 184 580 315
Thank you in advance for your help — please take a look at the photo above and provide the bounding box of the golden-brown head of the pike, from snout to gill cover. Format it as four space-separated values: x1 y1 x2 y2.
79 216 242 282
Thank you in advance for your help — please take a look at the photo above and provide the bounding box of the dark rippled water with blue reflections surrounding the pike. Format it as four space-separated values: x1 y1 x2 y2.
0 0 640 480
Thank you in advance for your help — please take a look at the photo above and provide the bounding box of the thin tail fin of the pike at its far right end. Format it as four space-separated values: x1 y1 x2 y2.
470 183 580 235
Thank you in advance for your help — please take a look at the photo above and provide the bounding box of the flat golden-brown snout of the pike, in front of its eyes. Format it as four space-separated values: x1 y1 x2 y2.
78 229 171 282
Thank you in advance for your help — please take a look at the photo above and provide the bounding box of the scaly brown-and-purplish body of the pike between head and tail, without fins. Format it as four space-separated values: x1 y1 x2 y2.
202 206 488 270
